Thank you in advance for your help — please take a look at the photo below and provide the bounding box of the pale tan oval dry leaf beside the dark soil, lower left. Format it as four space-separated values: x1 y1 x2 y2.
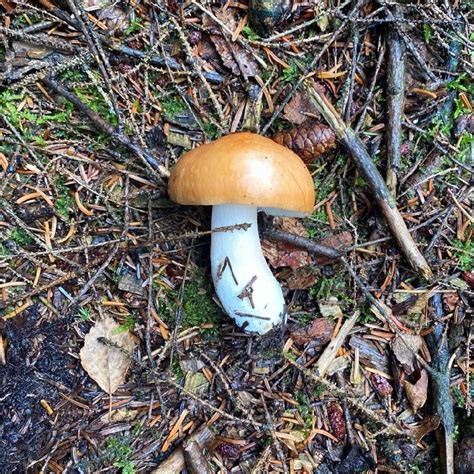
80 318 136 394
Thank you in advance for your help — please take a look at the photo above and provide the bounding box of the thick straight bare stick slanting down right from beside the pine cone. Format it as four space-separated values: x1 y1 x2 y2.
305 80 433 279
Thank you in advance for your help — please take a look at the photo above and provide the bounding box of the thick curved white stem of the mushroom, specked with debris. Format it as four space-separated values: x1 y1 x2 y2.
211 205 286 334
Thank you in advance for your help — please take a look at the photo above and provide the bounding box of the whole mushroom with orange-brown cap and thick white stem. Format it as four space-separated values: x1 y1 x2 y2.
168 132 315 334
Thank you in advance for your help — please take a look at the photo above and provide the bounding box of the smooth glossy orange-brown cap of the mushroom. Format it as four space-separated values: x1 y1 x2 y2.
168 132 315 215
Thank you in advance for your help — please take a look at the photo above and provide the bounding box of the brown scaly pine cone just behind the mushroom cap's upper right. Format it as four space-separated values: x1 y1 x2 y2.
273 123 336 164
